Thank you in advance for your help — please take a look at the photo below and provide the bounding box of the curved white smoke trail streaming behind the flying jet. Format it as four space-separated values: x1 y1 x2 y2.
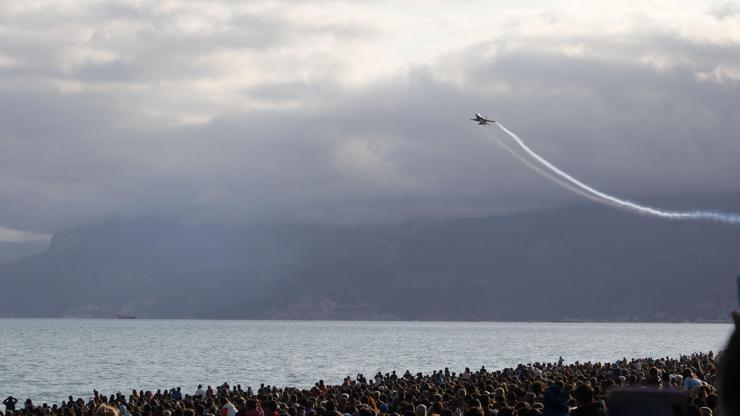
495 121 740 225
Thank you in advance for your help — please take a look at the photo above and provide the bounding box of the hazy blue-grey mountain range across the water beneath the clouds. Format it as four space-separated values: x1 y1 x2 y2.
0 194 740 321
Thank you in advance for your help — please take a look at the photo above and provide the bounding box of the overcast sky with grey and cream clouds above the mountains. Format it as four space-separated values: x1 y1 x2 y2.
0 0 740 241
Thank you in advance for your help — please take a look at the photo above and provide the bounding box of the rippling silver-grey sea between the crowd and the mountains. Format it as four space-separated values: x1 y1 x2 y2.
0 319 731 403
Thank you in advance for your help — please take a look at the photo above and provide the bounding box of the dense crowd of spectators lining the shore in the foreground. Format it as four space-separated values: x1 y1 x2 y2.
3 352 721 416
